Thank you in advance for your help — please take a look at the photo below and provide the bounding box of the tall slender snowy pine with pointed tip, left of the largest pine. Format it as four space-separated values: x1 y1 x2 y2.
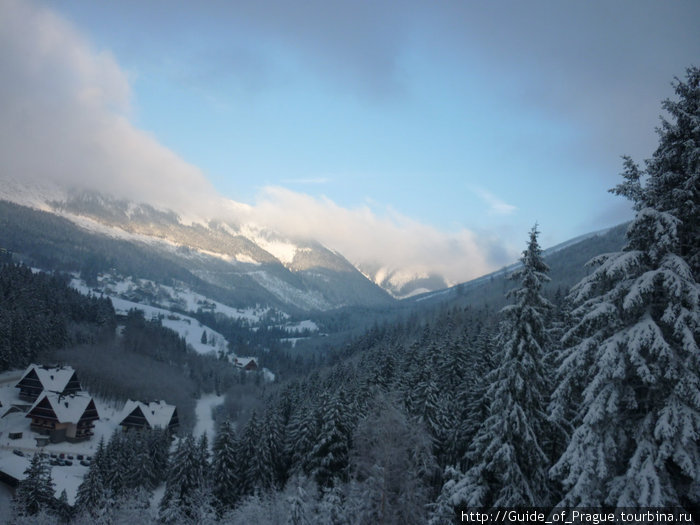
450 226 550 507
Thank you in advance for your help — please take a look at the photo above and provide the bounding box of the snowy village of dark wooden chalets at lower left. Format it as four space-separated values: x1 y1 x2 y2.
0 357 258 503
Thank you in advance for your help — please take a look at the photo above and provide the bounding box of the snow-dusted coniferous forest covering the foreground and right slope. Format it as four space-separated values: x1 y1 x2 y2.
5 67 700 525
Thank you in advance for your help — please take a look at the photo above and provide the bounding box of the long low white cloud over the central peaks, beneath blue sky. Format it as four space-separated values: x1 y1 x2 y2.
226 186 515 283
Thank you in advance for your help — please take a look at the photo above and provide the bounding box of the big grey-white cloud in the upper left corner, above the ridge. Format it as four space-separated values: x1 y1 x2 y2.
0 0 215 217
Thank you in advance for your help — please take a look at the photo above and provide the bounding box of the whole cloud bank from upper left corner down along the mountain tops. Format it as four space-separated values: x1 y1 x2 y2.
0 0 507 282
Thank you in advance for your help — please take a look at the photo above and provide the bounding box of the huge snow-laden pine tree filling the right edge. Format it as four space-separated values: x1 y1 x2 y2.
552 68 700 507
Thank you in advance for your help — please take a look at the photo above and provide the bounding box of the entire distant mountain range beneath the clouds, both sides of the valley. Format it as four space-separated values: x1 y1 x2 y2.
0 179 624 326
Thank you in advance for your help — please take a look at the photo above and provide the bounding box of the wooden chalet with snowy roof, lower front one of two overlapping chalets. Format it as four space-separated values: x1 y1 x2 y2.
25 392 100 443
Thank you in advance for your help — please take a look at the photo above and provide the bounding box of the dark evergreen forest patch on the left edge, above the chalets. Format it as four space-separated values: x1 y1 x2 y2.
0 257 115 371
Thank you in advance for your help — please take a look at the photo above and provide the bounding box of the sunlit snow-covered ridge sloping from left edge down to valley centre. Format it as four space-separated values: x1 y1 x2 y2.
0 183 393 311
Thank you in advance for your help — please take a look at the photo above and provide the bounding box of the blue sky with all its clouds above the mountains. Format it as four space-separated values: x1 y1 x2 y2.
0 0 700 283
